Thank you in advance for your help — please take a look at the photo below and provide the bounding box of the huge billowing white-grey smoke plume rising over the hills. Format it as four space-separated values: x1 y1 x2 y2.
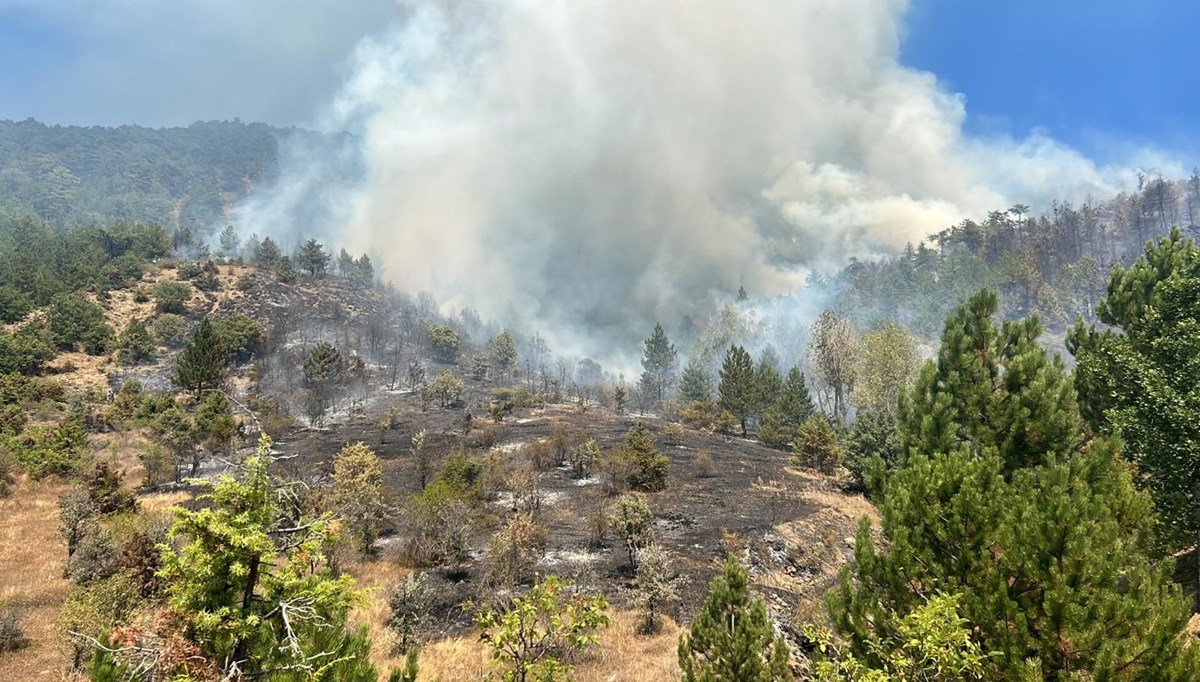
242 0 1169 357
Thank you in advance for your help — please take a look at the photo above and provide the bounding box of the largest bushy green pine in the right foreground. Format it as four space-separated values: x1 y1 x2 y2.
830 292 1200 680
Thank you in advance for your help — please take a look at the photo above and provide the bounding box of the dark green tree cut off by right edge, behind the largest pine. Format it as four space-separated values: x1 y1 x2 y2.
1068 229 1200 551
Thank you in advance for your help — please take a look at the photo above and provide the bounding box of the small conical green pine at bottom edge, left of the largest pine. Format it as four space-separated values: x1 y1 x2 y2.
679 557 791 682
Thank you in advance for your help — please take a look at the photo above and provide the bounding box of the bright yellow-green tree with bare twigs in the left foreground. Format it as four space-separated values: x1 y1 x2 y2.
158 437 358 680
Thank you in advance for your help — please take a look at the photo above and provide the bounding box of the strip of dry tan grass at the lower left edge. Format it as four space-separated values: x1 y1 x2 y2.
0 480 70 681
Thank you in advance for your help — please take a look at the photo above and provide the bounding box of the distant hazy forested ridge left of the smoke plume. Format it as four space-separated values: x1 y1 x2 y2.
0 119 350 231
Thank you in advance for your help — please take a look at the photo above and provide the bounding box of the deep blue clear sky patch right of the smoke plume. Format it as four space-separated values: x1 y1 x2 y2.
901 0 1200 157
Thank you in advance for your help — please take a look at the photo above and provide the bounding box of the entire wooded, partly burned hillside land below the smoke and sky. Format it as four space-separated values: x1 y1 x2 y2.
0 121 1200 682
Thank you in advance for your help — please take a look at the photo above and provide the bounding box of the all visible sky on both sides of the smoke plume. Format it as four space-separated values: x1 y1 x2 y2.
0 0 1200 165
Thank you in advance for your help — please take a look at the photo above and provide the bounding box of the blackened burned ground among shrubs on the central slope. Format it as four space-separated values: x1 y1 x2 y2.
267 387 874 634
